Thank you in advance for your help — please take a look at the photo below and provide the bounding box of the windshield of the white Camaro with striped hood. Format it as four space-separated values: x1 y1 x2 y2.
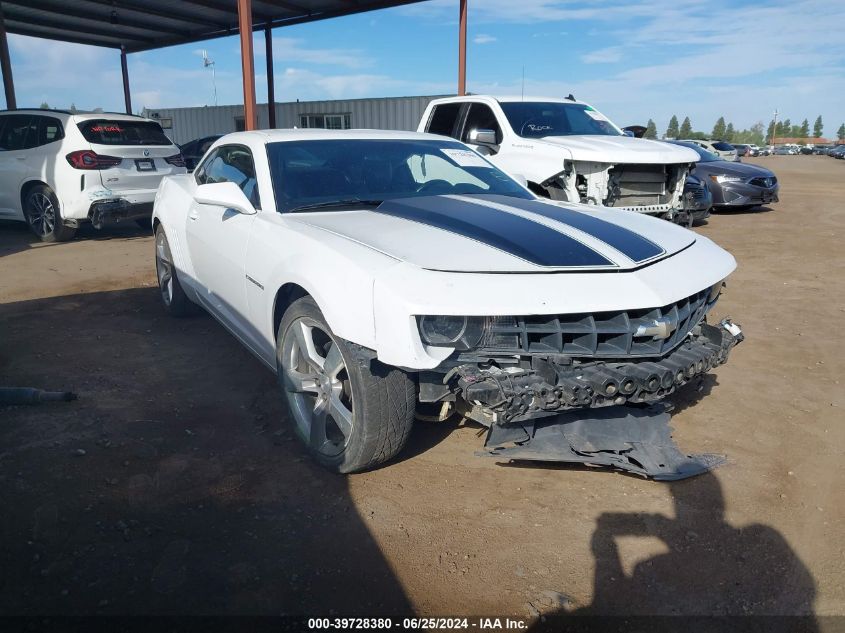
267 139 532 213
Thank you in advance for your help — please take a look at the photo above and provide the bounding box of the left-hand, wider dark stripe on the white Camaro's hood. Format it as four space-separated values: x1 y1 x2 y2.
373 196 615 268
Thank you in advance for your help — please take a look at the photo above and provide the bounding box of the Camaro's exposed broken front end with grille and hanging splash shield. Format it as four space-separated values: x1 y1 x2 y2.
420 284 743 480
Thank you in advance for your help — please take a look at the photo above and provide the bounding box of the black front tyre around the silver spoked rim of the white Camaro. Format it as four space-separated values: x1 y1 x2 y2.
276 296 416 473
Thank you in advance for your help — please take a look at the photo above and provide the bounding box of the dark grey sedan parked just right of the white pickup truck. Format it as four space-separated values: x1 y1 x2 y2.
667 141 779 209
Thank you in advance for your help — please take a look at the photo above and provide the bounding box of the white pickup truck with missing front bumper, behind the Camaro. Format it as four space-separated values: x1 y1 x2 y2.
418 95 698 220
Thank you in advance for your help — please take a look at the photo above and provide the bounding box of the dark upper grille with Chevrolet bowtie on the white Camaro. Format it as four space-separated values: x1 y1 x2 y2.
481 290 712 358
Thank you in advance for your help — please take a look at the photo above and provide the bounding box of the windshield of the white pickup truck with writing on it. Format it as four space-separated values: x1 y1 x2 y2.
500 101 624 138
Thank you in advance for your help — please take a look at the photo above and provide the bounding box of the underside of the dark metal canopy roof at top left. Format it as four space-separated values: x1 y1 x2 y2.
2 0 422 53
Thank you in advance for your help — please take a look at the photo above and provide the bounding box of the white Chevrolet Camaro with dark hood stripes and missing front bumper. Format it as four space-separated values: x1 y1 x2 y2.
153 130 741 472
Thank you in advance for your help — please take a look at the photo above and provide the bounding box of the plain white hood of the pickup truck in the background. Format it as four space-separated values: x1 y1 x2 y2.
537 135 698 165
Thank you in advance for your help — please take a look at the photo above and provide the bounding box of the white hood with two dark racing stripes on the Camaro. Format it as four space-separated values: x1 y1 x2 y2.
285 195 696 273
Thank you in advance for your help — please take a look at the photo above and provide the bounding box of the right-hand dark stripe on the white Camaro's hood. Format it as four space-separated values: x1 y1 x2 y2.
479 195 666 263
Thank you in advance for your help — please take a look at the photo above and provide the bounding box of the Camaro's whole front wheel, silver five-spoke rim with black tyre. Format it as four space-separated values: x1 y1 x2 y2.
276 297 416 473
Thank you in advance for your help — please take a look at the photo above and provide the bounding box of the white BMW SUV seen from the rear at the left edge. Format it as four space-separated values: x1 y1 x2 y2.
0 110 185 242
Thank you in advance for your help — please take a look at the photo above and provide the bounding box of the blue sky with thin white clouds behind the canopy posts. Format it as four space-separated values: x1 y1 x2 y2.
6 0 845 136
